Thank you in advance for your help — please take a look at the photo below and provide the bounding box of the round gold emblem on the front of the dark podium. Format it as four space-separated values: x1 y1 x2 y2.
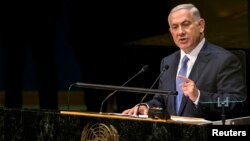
81 123 119 141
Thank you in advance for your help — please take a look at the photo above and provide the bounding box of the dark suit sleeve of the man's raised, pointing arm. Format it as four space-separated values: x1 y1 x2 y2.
198 51 246 114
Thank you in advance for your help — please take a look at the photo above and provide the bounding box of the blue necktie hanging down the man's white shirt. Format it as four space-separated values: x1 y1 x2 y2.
176 55 189 114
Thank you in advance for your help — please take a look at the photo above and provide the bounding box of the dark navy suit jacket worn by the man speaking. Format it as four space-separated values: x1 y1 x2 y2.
148 41 246 120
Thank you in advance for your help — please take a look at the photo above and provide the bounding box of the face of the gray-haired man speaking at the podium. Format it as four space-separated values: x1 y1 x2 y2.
169 9 205 53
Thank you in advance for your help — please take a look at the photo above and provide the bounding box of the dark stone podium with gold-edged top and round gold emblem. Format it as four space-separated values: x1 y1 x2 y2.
0 108 211 141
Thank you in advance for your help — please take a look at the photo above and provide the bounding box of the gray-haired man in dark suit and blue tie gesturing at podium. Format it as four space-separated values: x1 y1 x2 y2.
123 4 246 120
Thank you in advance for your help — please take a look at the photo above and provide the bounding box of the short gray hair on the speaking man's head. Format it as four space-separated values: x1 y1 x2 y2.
168 4 201 23
